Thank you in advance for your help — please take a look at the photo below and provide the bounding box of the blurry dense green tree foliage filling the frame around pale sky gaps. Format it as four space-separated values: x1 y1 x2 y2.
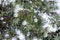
0 0 60 40
